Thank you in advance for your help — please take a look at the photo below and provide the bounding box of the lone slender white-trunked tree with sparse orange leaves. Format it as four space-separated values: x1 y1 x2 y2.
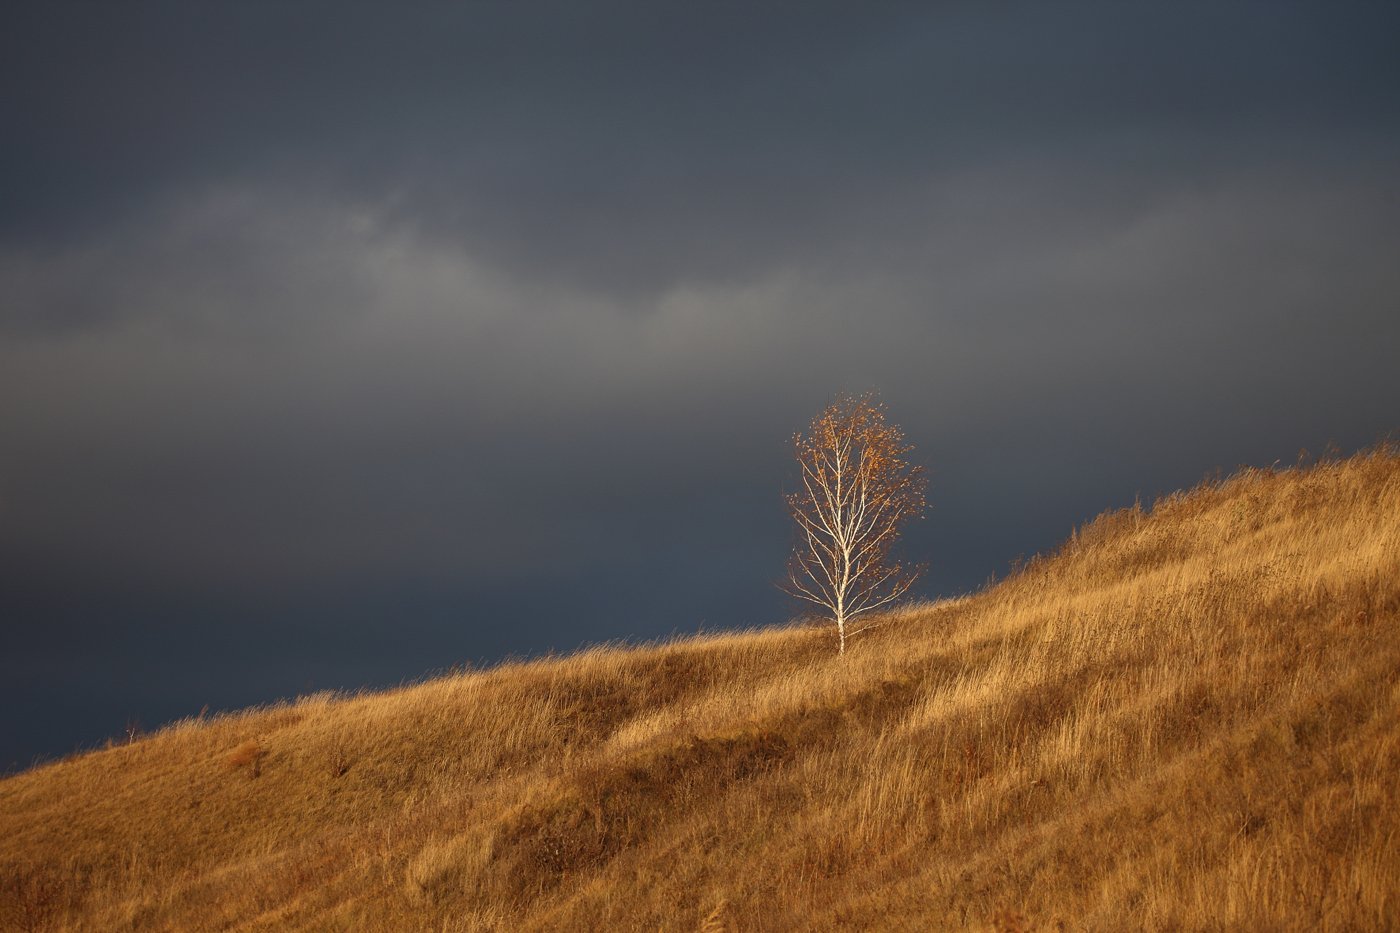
778 395 928 654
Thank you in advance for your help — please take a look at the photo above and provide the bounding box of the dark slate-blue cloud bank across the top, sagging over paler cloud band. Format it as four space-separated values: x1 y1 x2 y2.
3 4 1400 289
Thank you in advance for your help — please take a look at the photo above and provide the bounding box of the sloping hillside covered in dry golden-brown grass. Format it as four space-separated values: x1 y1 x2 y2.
8 451 1400 930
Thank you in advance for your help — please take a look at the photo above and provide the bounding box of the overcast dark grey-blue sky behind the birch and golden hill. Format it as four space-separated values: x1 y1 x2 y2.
0 1 1400 769
